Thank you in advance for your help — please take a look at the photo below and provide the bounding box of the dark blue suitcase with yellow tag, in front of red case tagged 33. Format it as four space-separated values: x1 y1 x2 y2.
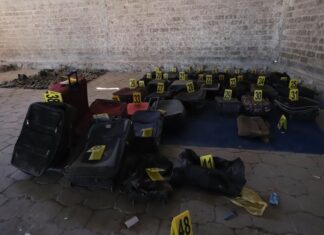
132 110 163 152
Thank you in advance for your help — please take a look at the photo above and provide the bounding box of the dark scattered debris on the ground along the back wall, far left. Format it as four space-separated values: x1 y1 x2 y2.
0 67 106 89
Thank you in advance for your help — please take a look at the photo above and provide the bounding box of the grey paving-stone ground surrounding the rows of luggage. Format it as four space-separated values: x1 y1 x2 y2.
0 73 324 235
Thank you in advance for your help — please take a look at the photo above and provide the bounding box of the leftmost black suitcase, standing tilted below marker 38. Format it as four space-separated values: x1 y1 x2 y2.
11 102 75 176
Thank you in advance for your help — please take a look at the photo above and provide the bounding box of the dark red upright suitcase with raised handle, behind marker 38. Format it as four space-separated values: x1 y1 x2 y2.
48 71 89 122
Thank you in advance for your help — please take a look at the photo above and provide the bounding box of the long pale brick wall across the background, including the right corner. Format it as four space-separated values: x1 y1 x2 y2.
0 0 324 81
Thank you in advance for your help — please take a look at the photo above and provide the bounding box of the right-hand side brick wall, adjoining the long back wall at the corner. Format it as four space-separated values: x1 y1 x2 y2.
280 0 324 81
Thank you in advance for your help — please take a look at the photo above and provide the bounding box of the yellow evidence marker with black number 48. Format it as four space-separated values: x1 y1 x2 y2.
170 210 193 235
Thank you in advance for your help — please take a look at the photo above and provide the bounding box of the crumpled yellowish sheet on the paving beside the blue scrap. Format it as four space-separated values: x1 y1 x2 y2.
230 187 268 216
